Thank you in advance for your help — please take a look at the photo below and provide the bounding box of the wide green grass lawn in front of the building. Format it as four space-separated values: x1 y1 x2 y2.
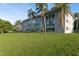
0 33 79 56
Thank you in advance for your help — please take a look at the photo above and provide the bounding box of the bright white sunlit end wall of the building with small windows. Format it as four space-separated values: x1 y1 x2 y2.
64 14 74 33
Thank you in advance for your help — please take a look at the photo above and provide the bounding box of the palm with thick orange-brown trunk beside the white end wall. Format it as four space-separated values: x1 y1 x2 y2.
55 3 70 30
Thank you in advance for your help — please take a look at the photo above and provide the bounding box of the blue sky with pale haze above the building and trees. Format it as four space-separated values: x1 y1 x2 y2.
0 3 79 24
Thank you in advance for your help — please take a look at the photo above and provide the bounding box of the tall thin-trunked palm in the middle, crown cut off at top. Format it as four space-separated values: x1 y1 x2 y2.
36 3 48 33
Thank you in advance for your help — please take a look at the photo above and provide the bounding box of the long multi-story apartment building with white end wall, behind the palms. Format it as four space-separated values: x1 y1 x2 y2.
19 8 74 33
